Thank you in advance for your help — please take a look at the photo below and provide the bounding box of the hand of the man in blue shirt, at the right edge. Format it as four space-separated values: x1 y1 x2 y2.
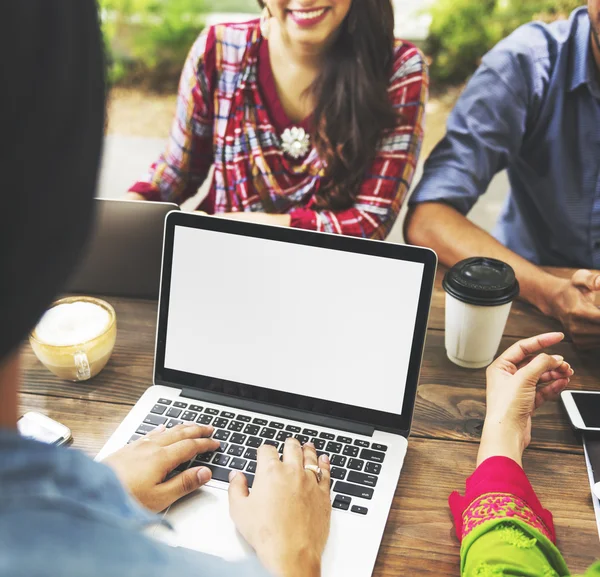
548 270 600 349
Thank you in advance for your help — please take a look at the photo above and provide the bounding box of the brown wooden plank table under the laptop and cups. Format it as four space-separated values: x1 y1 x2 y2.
21 270 600 576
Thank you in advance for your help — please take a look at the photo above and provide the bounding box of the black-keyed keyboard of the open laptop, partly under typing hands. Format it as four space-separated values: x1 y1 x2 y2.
128 399 387 515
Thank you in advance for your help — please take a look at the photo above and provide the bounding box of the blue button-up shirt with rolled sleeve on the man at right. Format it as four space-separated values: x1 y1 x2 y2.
410 8 600 268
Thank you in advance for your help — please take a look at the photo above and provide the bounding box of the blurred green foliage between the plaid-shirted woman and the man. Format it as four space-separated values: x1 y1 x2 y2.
425 0 584 83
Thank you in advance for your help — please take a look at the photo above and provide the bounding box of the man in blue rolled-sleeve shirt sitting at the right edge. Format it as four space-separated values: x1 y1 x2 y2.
405 0 600 345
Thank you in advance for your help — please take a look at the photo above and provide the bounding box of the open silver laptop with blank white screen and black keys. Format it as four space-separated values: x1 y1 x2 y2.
97 212 437 577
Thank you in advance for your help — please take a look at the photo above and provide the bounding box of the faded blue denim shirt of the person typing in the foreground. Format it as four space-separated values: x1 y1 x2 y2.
0 429 267 577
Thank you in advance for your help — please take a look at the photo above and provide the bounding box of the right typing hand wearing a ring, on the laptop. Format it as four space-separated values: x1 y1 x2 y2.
229 438 331 577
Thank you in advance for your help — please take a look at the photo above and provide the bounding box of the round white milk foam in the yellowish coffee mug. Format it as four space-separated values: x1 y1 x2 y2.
35 302 111 346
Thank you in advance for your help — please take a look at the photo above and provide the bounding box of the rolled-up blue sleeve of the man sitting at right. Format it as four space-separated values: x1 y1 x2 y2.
410 37 539 214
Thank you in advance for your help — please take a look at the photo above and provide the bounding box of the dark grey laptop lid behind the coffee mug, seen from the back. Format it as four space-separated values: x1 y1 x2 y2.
66 198 179 299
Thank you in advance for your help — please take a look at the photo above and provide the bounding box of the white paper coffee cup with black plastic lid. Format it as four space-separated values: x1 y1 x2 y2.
444 257 519 369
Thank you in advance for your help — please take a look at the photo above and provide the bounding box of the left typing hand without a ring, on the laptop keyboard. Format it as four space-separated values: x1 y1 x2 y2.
104 424 219 512
